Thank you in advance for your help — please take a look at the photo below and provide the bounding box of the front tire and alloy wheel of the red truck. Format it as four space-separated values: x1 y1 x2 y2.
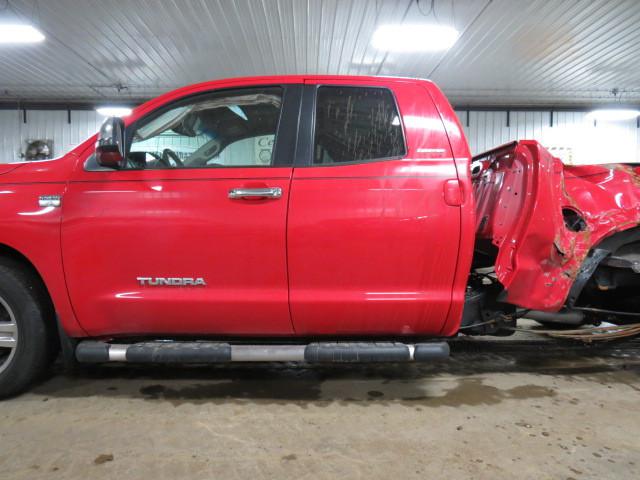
0 259 56 398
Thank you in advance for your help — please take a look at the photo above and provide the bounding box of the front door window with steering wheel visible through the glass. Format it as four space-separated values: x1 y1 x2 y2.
126 88 282 169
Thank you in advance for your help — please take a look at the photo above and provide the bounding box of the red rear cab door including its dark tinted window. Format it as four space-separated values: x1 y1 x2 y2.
287 79 460 335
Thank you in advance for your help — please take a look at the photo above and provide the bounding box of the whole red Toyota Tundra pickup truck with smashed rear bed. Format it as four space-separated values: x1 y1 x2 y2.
0 76 640 396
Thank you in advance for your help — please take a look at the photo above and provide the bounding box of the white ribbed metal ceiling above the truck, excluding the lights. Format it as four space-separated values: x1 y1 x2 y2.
0 0 640 105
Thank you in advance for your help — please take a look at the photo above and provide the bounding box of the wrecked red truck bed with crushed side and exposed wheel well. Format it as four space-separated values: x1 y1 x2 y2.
472 141 640 332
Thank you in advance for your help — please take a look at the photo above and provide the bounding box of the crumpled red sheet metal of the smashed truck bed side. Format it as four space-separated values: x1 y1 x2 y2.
475 141 640 311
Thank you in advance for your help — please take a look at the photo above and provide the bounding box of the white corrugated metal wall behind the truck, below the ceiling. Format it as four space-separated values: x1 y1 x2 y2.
0 110 640 163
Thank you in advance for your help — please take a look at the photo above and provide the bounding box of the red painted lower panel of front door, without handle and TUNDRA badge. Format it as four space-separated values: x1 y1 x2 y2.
62 163 293 336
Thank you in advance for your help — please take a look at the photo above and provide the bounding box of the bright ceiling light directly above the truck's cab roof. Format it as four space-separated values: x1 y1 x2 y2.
371 24 458 52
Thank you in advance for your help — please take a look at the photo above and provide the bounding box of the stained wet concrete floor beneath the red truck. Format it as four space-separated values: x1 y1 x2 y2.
0 332 640 480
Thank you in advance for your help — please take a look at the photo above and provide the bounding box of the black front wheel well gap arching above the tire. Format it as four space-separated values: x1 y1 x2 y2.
0 243 60 360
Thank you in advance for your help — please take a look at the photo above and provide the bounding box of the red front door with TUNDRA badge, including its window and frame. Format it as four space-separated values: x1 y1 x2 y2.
62 85 302 335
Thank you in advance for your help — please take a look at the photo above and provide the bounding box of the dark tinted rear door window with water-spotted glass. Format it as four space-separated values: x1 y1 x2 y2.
313 87 405 165
